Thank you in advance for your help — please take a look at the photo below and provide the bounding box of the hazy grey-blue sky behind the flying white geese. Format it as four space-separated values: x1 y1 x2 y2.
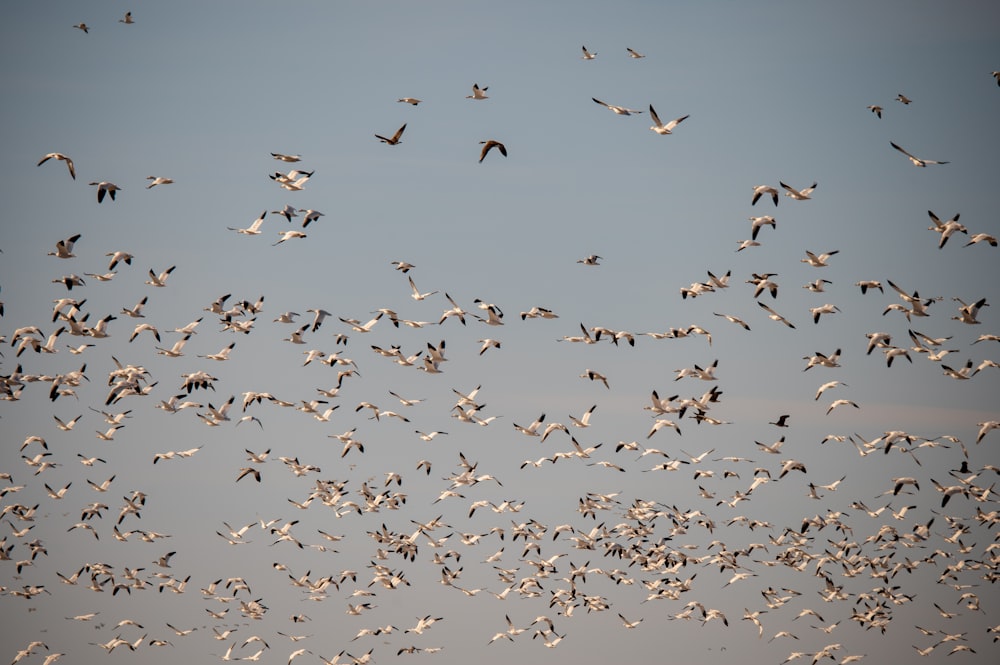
0 1 1000 665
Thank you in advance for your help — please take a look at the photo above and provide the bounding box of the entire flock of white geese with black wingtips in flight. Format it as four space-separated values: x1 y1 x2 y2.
0 13 1000 665
